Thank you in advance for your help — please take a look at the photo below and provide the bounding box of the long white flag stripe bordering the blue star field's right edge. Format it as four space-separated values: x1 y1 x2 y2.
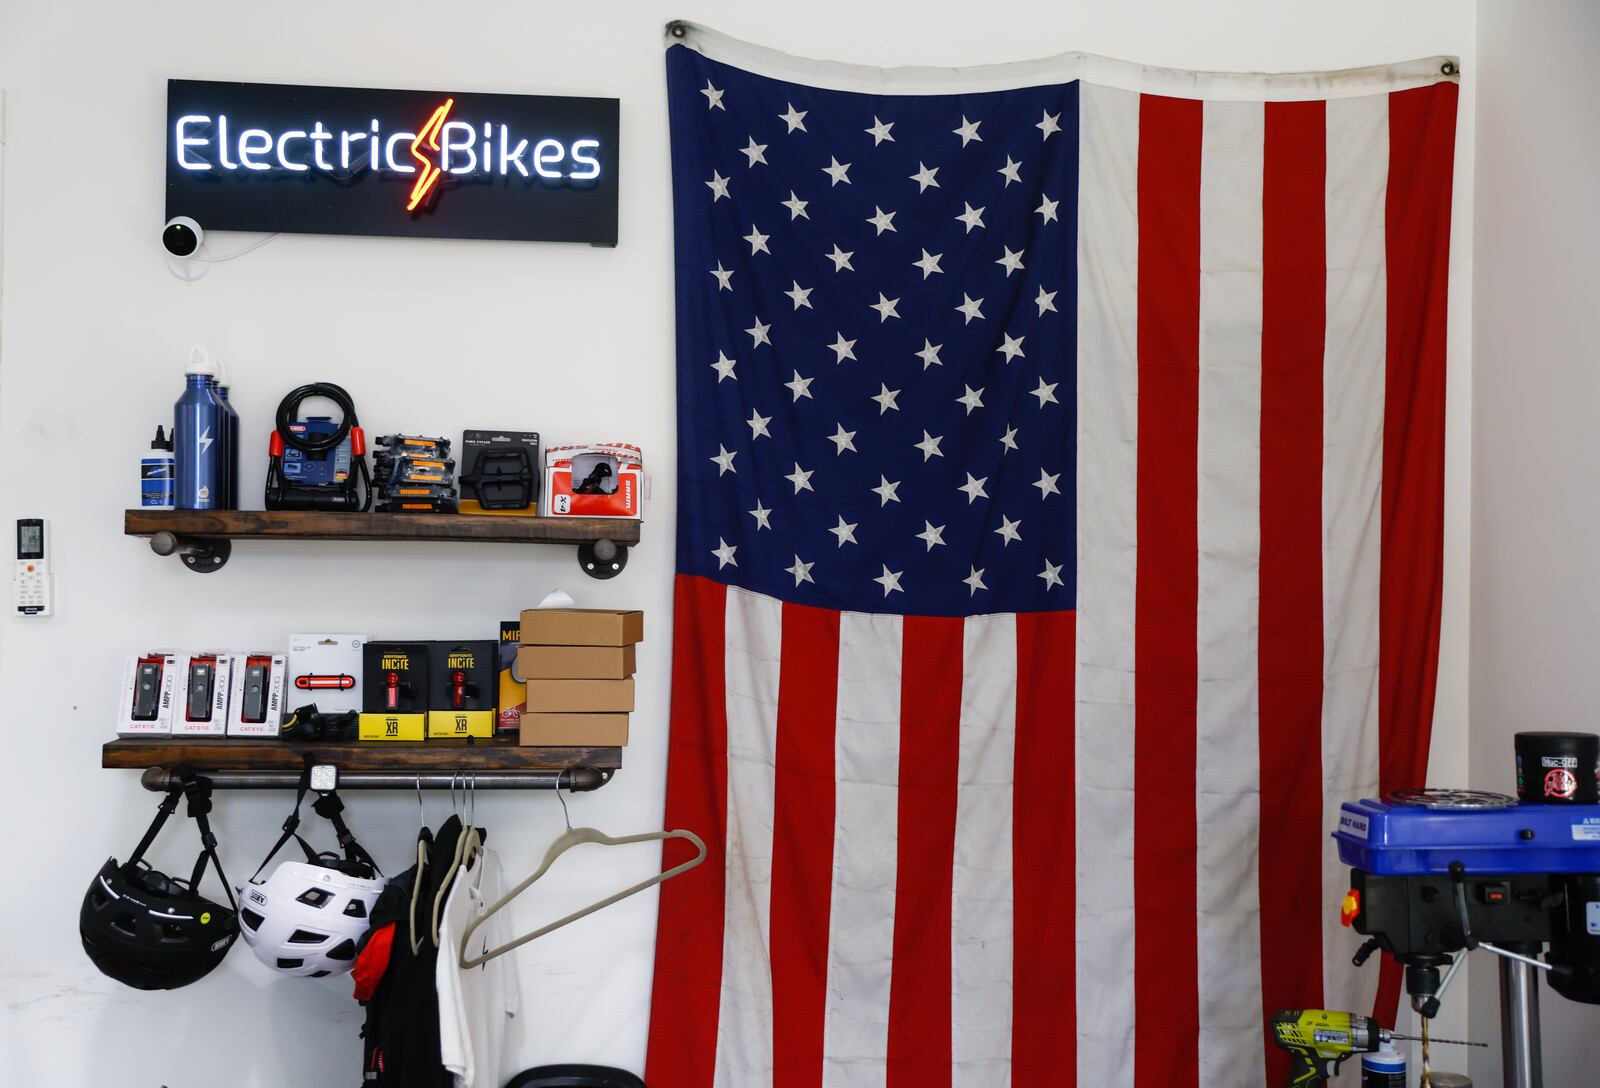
1062 83 1160 1088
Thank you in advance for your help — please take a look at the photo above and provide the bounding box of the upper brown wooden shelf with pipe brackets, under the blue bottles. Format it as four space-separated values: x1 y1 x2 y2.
123 510 640 578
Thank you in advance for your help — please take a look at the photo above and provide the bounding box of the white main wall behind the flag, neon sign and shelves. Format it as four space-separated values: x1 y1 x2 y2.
0 0 1472 1088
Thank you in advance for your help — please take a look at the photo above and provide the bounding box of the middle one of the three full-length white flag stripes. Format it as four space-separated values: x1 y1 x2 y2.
1195 102 1270 1085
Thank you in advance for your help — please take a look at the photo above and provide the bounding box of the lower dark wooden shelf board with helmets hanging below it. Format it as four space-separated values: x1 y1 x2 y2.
101 736 622 774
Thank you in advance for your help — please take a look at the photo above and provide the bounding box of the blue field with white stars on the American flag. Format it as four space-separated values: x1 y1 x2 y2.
667 48 1078 616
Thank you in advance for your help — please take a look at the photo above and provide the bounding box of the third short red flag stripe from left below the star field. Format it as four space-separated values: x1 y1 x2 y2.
886 616 963 1088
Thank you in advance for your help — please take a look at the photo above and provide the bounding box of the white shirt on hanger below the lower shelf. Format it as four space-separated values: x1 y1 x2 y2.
434 848 520 1088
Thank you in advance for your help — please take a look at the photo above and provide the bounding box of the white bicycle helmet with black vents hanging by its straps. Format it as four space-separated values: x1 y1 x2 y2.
238 782 387 978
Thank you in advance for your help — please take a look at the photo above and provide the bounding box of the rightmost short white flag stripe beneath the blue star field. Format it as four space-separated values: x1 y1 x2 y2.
950 613 1016 1088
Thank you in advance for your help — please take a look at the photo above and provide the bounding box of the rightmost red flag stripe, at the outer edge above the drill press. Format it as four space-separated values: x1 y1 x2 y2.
1374 83 1459 1022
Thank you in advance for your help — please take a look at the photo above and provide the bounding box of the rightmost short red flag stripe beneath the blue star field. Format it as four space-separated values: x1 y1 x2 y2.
1011 613 1078 1088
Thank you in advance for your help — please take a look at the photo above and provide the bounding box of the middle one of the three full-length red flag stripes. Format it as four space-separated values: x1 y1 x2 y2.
1258 102 1328 1085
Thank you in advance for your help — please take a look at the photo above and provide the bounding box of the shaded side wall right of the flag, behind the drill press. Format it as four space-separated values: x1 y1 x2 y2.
1472 0 1600 1088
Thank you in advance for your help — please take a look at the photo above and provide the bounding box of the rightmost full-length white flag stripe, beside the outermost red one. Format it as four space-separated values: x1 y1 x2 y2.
1322 94 1389 1010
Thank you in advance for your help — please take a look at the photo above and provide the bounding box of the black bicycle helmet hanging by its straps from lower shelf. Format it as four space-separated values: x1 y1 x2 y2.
78 774 238 990
